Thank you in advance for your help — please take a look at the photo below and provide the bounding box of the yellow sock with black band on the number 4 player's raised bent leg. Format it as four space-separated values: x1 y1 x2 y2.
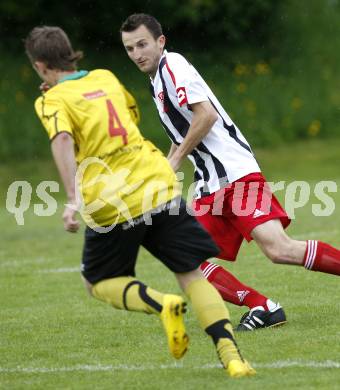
92 276 164 314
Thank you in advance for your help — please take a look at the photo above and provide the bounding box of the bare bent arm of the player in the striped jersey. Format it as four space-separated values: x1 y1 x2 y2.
169 101 218 171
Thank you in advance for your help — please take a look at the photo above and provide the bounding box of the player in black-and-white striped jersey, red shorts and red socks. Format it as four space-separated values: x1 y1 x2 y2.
120 14 340 331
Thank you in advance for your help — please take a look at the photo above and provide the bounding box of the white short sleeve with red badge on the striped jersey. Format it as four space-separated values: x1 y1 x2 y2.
165 53 209 107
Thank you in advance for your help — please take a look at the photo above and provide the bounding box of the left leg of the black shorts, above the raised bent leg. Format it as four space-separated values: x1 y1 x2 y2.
82 224 146 284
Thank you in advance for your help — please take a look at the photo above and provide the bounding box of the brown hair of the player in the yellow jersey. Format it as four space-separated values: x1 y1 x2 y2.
24 26 83 71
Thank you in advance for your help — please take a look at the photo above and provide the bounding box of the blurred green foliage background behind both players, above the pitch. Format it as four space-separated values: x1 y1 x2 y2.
0 0 340 161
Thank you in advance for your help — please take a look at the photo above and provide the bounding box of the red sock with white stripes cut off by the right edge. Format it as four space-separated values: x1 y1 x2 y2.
303 240 340 275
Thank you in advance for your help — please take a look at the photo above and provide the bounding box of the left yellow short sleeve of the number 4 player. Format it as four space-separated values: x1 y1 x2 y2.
34 93 73 140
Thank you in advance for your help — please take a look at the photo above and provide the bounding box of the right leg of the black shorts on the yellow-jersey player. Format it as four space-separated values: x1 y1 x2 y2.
143 200 219 273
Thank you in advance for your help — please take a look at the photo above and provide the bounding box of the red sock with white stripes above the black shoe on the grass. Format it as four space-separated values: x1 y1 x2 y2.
201 261 268 310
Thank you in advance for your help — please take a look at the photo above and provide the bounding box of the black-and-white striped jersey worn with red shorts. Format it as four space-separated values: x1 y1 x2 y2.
151 50 260 198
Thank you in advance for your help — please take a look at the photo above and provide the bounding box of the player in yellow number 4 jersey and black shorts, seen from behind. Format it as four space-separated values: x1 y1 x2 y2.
25 26 255 377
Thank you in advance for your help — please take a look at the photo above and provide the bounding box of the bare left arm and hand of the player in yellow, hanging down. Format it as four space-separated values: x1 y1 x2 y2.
51 132 80 233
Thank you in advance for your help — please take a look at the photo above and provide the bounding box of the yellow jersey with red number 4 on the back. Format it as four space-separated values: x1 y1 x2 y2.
35 69 179 224
